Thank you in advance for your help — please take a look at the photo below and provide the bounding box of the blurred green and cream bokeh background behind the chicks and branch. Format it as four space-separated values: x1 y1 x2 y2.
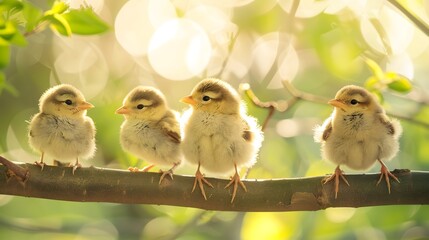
0 0 429 239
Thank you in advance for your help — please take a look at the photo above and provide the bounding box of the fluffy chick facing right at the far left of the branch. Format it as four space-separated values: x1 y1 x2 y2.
28 84 95 174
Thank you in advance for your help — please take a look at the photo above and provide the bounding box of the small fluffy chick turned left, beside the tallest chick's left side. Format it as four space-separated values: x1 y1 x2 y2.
116 86 183 184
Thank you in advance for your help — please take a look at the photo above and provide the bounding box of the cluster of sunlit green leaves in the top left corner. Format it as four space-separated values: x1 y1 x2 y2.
0 0 109 93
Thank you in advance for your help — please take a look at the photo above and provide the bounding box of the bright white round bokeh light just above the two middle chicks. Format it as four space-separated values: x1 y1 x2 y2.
148 19 212 80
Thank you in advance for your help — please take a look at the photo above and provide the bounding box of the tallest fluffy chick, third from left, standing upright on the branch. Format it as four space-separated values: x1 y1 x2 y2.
182 78 263 203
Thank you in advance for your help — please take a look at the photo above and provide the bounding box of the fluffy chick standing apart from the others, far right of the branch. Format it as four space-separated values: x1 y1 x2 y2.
314 85 402 198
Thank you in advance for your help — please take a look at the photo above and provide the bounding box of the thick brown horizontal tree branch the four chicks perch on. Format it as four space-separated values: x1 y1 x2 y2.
0 158 429 212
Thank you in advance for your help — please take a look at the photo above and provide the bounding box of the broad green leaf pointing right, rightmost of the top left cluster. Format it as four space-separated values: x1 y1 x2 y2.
63 8 109 35
